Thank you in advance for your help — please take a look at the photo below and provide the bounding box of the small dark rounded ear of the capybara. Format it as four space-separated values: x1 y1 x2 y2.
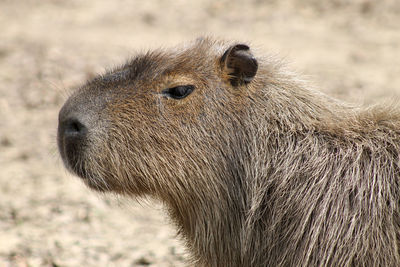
221 44 258 86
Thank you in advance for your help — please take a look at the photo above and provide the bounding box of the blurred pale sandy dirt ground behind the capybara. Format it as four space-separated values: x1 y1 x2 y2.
0 0 400 266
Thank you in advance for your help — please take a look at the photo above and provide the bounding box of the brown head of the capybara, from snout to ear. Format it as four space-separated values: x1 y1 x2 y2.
58 39 258 200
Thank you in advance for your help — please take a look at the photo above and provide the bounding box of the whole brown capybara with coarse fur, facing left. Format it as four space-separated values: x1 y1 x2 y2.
58 38 400 267
